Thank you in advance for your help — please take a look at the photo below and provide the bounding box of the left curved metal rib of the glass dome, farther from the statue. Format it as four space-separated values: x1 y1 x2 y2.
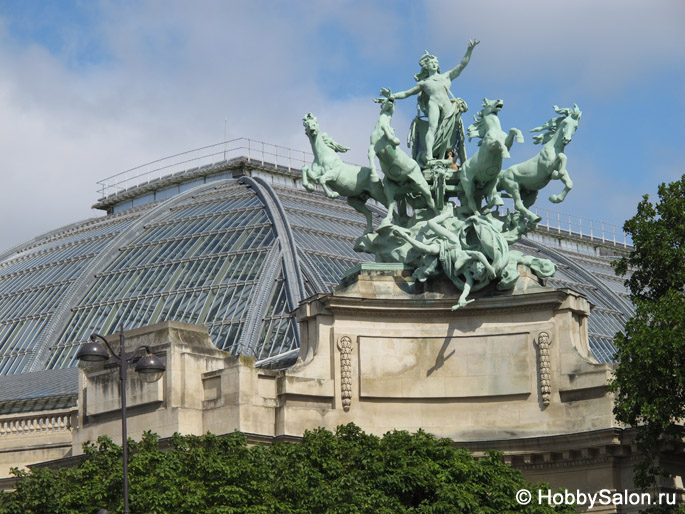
24 179 240 373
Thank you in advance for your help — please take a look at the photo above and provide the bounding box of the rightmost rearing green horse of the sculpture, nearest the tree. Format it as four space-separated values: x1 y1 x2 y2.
497 104 582 223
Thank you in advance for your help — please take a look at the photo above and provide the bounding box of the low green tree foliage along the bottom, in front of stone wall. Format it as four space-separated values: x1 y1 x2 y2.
0 424 574 514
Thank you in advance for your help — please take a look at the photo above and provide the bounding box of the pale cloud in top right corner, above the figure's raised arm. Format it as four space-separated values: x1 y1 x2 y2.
425 0 685 90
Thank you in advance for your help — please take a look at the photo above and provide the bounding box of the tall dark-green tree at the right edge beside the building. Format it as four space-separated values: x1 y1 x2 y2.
611 175 685 498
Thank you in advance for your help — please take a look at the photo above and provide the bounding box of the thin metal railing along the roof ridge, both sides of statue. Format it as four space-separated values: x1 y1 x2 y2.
97 137 631 246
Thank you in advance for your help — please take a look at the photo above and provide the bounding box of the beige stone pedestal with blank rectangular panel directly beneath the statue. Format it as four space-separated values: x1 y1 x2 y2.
292 264 615 441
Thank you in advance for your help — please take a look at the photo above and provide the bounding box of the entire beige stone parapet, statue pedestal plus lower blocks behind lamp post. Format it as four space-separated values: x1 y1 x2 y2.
73 264 615 444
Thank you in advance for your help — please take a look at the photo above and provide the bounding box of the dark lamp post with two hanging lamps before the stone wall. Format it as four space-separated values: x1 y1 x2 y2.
76 326 166 514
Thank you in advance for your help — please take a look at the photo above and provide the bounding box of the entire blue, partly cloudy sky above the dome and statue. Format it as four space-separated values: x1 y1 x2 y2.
0 0 685 251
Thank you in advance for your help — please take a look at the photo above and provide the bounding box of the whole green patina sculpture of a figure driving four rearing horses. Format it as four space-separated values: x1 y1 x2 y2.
302 40 581 309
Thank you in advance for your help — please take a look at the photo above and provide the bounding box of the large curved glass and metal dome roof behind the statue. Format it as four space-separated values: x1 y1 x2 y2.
0 148 632 388
